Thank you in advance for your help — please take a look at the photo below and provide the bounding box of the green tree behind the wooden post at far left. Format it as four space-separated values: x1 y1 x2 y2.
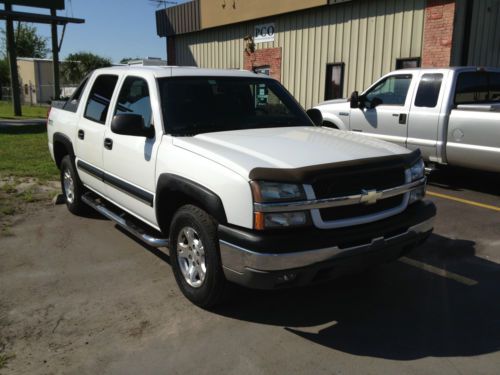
1 22 49 59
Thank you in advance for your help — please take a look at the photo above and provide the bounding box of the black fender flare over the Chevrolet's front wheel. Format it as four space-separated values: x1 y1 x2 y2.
155 173 227 234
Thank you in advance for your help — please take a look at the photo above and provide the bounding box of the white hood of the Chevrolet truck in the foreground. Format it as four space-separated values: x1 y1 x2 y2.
173 126 409 178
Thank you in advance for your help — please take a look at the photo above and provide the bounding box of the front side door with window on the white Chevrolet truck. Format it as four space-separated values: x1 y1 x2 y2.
103 76 162 225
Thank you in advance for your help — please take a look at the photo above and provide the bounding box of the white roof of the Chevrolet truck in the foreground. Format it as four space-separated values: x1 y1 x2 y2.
91 65 270 78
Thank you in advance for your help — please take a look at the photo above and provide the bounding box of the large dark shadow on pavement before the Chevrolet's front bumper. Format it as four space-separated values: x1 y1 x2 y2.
212 235 500 360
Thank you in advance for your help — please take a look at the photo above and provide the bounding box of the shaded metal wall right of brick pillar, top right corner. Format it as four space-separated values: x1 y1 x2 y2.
467 0 500 67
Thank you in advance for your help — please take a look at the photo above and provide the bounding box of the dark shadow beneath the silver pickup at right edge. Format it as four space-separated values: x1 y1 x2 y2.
429 167 500 196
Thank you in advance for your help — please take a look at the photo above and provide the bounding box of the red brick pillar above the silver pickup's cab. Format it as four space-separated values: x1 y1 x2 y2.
422 0 455 67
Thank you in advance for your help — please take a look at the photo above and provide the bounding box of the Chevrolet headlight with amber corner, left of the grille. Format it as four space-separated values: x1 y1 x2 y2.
251 181 305 202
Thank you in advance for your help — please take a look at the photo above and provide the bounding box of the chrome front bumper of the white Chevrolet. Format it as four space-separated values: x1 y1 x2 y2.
219 217 434 279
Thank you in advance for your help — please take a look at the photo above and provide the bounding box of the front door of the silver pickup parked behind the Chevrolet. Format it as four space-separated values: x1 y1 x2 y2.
350 74 413 147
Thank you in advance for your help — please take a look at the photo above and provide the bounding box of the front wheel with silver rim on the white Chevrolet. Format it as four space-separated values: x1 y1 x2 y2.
170 205 227 308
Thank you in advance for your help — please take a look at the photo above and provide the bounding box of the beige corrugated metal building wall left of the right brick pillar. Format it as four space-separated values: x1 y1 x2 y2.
176 0 425 108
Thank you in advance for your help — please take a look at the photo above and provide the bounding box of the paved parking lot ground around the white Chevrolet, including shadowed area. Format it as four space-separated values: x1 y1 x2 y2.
0 170 500 374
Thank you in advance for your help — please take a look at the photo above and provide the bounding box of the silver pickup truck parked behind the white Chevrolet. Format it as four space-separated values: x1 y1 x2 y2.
315 67 500 172
